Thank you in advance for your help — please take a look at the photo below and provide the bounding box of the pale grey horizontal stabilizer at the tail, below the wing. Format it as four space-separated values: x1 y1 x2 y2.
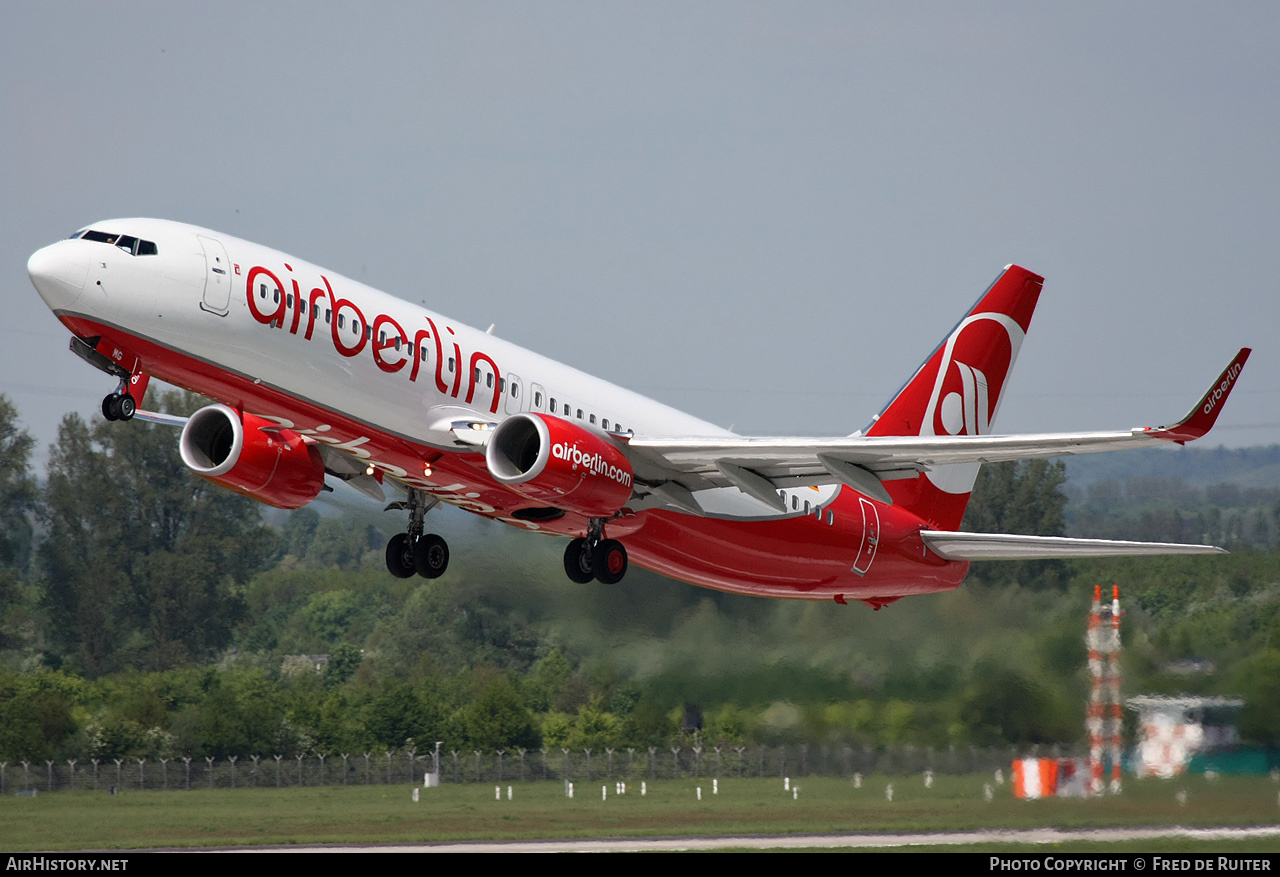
920 530 1226 561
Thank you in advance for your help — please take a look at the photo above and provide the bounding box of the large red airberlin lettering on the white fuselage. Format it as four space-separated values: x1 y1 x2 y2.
236 262 503 414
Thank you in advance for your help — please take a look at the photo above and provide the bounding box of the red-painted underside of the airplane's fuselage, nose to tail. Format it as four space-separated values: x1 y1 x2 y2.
59 314 969 604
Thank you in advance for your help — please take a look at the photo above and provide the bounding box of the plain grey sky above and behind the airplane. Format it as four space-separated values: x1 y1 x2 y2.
0 3 1280 471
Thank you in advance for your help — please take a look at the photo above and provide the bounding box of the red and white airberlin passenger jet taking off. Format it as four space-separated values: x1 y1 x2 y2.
27 219 1249 609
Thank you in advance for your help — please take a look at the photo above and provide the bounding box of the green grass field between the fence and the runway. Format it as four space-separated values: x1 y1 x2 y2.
0 776 1280 851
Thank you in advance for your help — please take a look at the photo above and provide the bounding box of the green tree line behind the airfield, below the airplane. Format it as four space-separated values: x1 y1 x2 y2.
0 394 1280 759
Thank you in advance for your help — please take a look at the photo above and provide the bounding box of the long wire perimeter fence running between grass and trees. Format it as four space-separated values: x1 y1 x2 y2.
0 744 1084 794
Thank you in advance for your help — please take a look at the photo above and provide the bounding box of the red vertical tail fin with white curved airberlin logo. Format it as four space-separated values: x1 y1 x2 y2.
867 265 1044 530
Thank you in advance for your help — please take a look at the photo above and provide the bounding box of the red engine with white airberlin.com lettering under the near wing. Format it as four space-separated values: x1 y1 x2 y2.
485 414 634 517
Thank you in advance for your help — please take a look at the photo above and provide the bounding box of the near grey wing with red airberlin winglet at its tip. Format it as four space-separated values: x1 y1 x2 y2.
627 347 1251 506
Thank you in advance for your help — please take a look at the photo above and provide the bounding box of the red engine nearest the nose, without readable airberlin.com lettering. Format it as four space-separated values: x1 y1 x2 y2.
179 405 324 508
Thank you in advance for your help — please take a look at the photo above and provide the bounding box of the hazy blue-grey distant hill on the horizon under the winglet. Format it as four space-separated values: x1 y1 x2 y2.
1062 444 1280 489
